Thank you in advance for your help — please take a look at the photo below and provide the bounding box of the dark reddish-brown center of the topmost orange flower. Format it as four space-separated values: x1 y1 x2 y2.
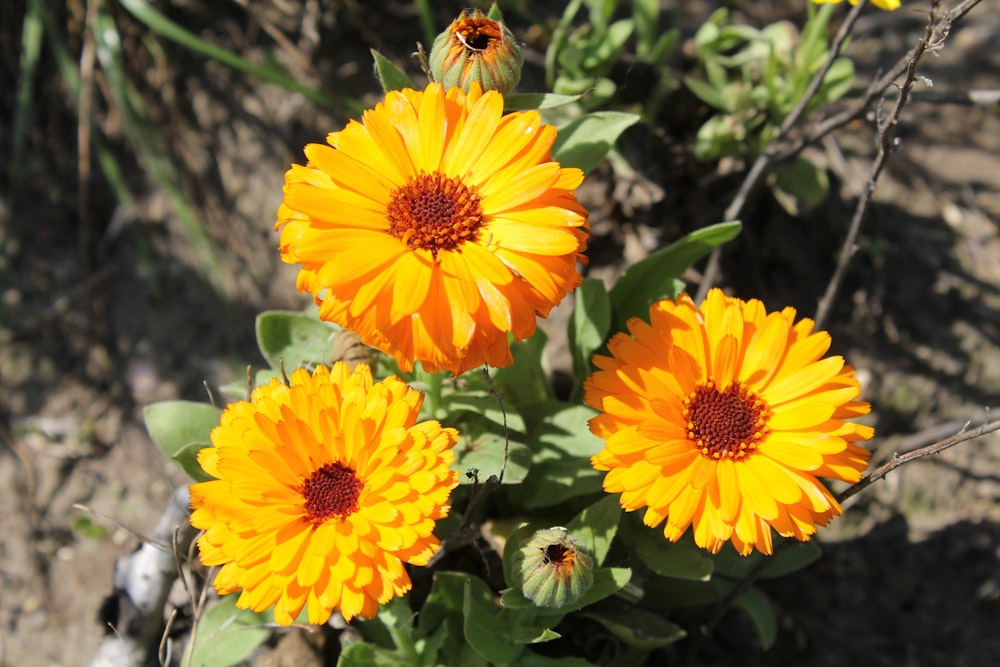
386 172 485 257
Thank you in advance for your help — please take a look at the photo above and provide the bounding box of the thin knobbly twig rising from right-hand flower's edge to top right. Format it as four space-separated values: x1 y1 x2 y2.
814 0 944 329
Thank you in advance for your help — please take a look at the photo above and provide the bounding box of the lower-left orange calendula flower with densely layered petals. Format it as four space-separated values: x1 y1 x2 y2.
191 362 458 625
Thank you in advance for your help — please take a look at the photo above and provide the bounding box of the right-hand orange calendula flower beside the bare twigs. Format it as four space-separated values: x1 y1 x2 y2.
584 289 873 555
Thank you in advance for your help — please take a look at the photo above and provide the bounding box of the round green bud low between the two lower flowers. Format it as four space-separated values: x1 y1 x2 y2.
512 527 594 607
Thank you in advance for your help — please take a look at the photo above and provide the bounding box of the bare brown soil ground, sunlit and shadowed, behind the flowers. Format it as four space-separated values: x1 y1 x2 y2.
0 0 1000 667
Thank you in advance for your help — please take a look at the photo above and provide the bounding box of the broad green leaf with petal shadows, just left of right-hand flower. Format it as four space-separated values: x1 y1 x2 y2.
515 401 604 509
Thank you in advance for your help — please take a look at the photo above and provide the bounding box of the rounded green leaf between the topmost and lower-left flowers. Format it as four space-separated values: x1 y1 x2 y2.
257 310 338 373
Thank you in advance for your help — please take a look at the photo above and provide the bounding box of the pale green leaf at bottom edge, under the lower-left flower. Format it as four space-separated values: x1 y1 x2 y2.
183 595 274 667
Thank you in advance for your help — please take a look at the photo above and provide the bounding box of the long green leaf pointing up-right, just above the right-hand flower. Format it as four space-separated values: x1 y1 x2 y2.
611 222 740 331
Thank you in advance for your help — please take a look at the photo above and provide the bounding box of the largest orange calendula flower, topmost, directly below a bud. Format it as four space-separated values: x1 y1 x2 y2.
276 83 589 374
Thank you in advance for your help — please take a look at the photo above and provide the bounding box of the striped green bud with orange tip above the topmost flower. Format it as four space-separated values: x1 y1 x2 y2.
430 9 524 95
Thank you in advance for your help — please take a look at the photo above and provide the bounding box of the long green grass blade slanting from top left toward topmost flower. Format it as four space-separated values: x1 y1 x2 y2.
120 0 364 114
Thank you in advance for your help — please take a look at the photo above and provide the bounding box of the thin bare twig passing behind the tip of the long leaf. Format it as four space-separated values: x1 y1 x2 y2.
695 0 867 303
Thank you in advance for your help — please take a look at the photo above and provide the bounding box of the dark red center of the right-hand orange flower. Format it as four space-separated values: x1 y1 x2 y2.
684 381 771 461
